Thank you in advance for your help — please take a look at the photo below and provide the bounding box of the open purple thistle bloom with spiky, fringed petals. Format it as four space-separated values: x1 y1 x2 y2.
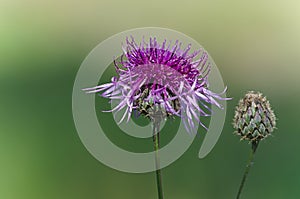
83 37 230 133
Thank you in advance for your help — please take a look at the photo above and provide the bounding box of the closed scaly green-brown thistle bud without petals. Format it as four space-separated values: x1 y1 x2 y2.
233 91 276 142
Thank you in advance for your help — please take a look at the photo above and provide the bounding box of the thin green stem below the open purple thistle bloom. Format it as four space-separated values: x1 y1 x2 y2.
153 122 164 199
